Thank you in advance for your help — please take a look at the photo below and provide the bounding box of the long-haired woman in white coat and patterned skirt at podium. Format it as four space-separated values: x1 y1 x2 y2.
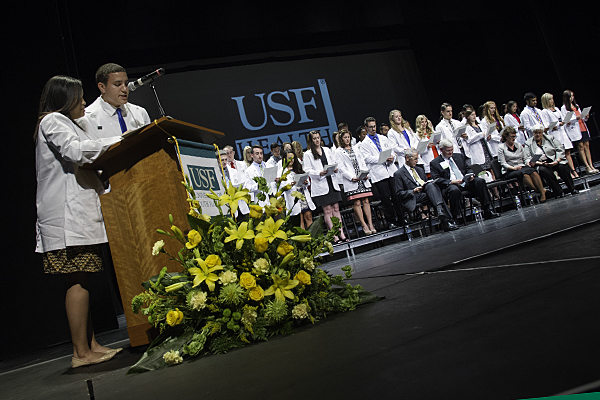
34 76 121 368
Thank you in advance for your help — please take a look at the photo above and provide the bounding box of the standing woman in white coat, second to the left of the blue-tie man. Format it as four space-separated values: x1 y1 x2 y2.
304 131 348 243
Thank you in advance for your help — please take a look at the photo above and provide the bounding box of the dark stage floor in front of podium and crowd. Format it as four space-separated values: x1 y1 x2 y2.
0 186 600 400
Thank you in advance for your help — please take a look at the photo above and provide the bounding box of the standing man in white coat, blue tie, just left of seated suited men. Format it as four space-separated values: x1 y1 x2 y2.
360 117 404 229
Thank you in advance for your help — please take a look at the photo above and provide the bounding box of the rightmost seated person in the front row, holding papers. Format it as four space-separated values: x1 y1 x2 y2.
523 124 579 197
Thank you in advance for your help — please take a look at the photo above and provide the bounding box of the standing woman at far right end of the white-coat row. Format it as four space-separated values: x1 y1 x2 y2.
560 90 599 174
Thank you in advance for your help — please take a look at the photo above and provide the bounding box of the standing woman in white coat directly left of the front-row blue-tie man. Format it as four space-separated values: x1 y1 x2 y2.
337 130 377 235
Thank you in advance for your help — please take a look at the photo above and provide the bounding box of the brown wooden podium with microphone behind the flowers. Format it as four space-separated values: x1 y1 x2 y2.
86 117 224 346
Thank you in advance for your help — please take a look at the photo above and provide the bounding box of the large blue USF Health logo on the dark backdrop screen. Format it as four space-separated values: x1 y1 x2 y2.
231 79 337 159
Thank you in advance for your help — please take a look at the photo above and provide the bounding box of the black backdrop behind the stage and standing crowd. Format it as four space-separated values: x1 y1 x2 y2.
0 0 600 359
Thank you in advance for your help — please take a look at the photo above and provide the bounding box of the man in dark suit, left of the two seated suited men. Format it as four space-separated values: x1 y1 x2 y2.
394 149 458 232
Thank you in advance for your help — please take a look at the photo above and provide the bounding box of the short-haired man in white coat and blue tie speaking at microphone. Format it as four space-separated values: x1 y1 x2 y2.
84 63 150 138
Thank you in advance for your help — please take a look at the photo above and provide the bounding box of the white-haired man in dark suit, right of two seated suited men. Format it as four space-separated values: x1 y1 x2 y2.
429 139 499 219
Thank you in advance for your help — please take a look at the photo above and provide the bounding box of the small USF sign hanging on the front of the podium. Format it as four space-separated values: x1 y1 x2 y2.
179 140 227 216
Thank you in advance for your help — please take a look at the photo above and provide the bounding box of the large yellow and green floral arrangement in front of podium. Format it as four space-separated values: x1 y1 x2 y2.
128 161 377 373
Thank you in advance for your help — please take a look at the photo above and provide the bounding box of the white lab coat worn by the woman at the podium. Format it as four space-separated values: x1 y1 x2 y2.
35 112 121 253
